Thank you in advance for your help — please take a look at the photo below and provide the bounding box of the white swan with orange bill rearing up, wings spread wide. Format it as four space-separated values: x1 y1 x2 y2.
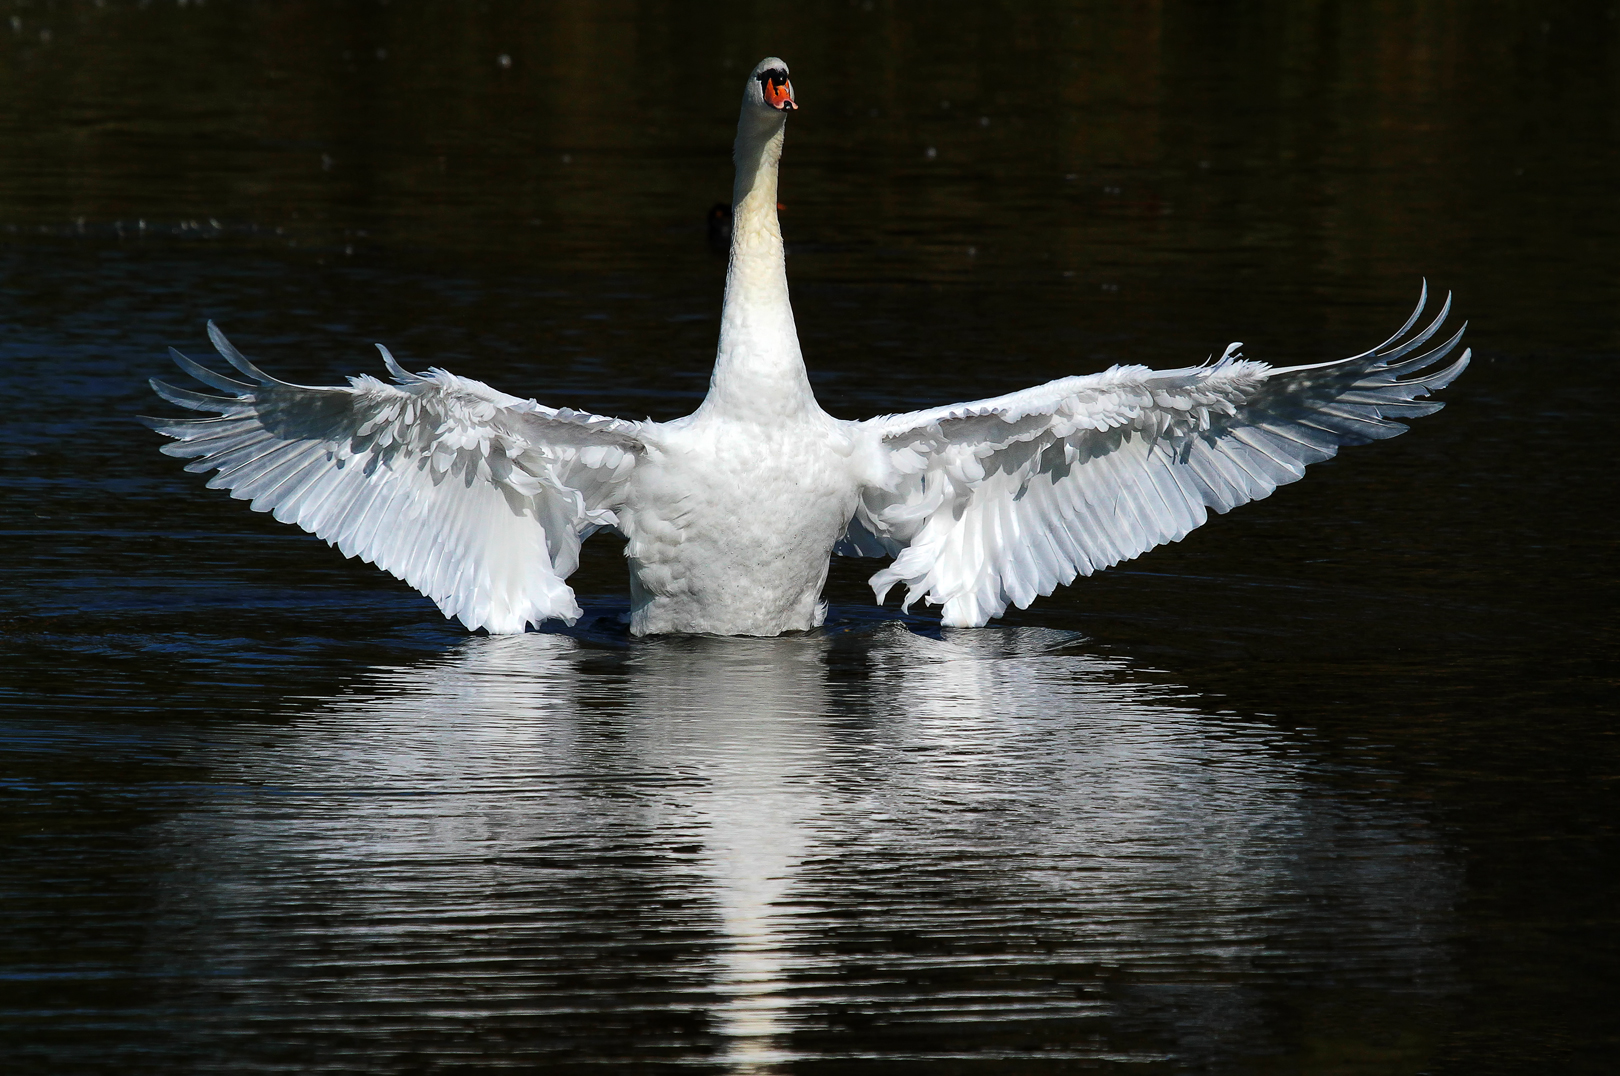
147 57 1469 635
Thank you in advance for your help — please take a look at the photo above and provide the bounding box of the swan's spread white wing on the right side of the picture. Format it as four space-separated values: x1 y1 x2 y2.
839 285 1469 627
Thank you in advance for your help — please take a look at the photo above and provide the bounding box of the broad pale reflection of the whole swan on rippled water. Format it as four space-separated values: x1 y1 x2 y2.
119 624 1456 1073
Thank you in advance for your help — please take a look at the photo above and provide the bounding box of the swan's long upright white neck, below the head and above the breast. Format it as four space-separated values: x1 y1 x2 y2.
701 105 816 420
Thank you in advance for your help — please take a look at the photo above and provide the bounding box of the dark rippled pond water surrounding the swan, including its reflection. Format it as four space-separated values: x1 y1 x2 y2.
0 0 1620 1076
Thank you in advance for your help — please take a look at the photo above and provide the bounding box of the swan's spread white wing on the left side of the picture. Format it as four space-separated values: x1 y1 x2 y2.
146 322 643 634
